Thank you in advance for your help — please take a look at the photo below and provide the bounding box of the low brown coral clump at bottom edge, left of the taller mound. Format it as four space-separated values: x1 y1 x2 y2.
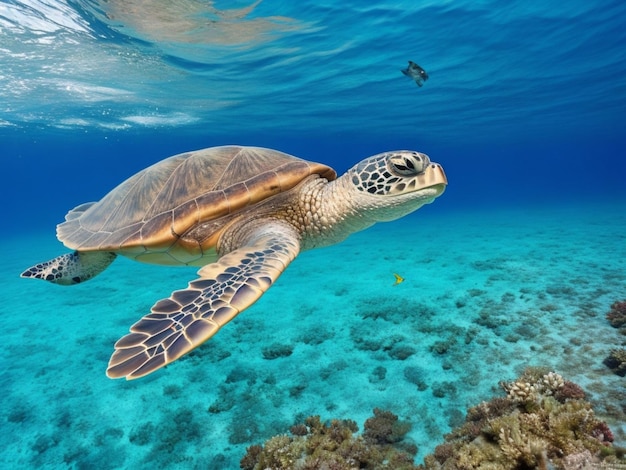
240 408 418 470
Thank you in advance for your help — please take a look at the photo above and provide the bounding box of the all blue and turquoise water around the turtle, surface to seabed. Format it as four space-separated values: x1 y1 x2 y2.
0 0 626 468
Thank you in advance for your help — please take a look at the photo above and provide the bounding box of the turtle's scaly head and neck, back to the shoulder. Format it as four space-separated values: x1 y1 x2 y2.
218 152 447 254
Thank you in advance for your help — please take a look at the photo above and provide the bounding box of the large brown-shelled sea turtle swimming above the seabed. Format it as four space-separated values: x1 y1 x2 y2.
22 146 447 379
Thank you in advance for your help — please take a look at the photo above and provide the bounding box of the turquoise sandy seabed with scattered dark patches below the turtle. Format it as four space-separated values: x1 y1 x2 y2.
0 204 626 468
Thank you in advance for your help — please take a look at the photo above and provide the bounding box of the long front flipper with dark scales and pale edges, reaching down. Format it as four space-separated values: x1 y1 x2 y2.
107 223 300 380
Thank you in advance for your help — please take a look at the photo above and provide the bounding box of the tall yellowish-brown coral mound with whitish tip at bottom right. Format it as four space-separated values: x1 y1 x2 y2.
419 368 626 470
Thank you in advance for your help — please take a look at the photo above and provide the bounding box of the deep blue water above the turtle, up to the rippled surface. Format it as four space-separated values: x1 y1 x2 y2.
0 0 626 222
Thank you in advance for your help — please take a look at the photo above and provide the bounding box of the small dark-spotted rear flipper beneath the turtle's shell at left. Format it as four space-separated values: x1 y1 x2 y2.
20 251 117 286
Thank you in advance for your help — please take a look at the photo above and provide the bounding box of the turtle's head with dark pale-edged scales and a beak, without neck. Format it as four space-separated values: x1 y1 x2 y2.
345 150 448 222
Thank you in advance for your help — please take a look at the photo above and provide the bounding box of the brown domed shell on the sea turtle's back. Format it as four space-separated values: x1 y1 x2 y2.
57 146 336 264
